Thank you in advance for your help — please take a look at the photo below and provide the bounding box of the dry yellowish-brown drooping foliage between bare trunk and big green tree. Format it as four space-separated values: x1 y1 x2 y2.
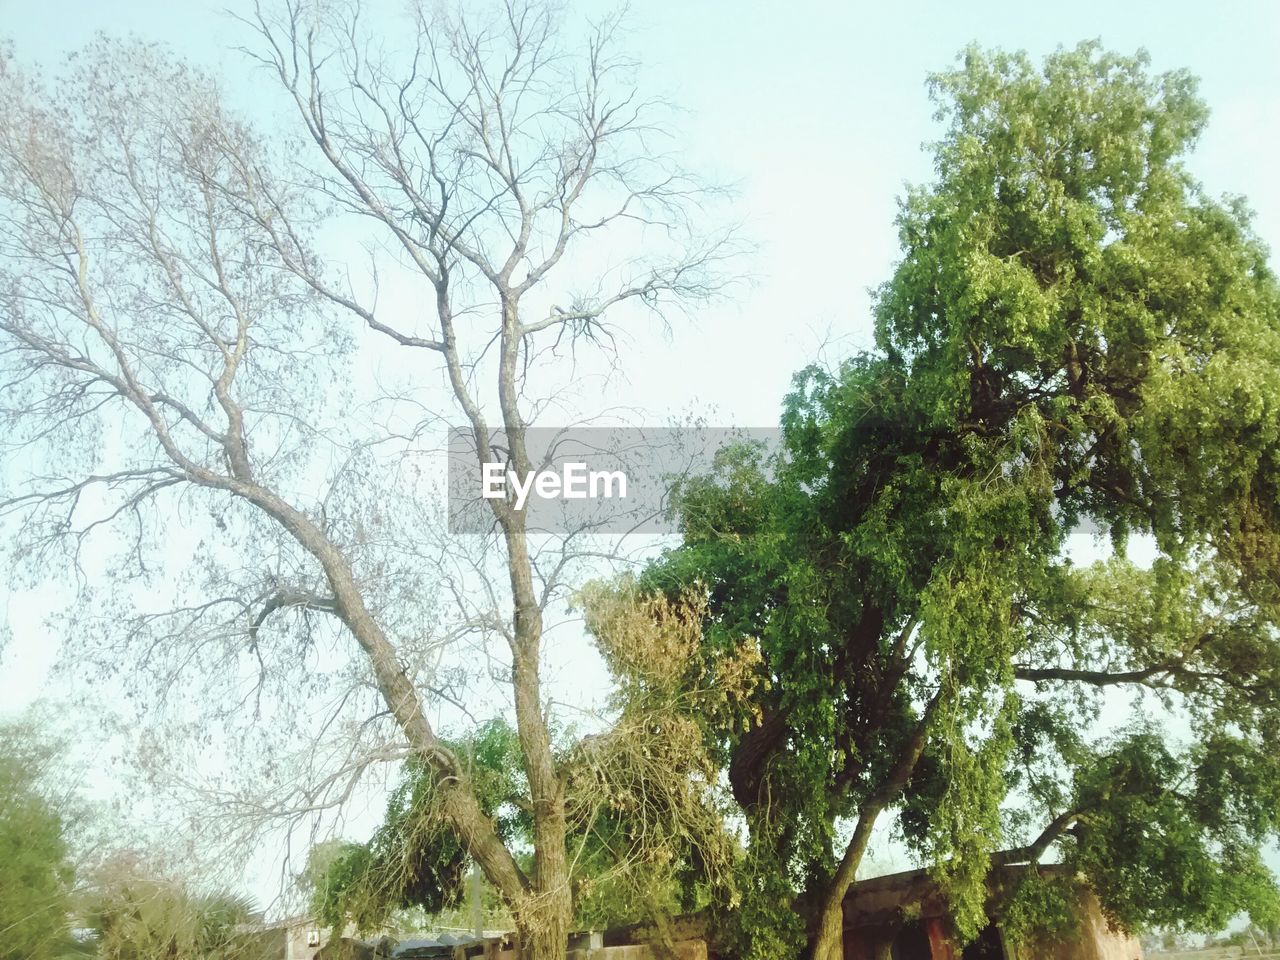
564 575 759 929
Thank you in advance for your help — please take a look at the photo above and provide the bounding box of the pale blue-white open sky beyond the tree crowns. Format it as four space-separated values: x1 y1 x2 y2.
0 0 1280 916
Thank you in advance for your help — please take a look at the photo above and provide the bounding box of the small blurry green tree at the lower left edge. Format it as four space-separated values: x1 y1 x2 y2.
0 722 73 960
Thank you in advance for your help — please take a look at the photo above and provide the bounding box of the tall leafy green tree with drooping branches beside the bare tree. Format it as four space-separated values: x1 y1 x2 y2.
644 44 1280 960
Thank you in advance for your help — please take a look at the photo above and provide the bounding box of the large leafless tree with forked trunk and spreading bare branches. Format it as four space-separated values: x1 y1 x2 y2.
0 0 728 959
